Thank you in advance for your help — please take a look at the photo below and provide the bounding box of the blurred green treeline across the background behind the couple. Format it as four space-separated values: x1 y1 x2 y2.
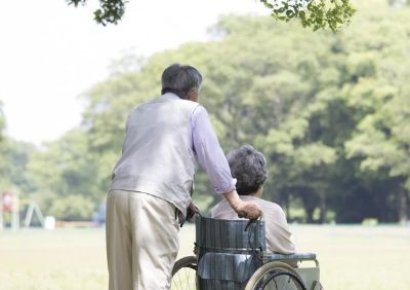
0 0 410 223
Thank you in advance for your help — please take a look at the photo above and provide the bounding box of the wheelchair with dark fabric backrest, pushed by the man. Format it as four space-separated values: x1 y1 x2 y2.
171 215 322 290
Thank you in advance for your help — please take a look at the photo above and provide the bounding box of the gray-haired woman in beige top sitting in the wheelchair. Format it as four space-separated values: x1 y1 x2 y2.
211 145 295 254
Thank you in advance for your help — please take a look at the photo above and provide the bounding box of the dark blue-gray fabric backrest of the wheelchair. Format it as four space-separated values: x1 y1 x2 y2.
195 216 266 290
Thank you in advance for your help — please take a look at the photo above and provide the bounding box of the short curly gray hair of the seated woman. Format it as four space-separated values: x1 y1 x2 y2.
227 144 268 195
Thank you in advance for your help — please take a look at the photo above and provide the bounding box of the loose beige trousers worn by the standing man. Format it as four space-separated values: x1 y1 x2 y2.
106 190 179 290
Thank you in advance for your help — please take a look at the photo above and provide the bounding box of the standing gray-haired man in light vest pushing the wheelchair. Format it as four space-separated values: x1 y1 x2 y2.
106 64 261 290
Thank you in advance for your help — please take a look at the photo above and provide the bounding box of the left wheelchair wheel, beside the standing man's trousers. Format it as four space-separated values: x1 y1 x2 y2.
171 256 197 290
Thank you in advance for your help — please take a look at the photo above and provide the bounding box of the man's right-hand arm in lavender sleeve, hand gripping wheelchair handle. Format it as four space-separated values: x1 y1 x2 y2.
192 106 261 219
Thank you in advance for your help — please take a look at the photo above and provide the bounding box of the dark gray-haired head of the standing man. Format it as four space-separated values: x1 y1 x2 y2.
161 64 202 101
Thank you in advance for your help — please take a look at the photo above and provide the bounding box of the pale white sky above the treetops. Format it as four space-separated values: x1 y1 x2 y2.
0 0 268 145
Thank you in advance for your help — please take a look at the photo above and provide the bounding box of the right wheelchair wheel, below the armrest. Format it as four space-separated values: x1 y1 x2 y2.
245 262 307 290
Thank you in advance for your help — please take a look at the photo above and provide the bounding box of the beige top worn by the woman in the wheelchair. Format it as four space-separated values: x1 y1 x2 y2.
211 195 295 254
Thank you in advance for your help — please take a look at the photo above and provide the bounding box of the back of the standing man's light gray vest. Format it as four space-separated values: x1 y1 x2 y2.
111 93 198 212
